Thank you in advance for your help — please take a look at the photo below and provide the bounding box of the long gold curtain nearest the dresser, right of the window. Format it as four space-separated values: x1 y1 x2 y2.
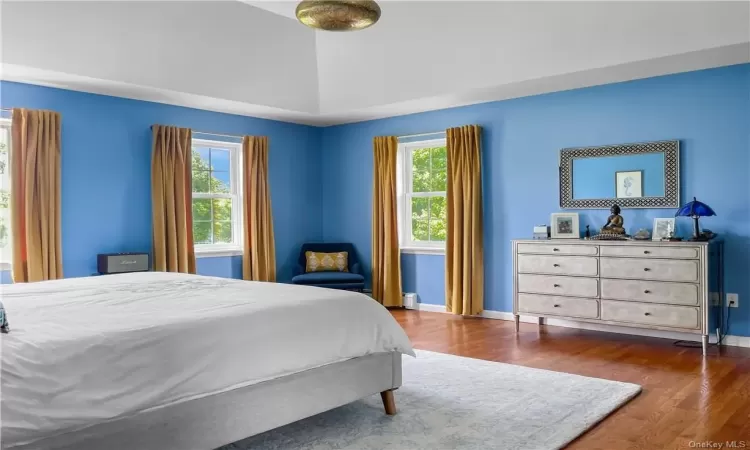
445 125 484 315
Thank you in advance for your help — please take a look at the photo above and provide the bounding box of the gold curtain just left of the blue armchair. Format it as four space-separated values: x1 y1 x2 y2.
242 136 276 281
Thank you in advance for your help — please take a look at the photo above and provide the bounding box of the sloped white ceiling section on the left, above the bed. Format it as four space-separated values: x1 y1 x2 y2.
1 1 318 113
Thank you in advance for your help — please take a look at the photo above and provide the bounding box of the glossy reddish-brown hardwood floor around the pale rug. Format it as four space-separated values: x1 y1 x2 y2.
391 310 750 450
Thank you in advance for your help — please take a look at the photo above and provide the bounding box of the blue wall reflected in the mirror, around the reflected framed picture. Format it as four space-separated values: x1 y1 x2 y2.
573 153 664 199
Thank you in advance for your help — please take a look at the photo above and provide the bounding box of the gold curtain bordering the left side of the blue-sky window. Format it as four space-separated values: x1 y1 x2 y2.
151 125 195 273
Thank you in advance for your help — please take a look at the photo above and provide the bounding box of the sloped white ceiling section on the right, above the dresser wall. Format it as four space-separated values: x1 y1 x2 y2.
316 1 750 114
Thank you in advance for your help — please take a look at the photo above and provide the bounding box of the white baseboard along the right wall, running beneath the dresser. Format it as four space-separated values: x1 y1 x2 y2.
416 303 750 348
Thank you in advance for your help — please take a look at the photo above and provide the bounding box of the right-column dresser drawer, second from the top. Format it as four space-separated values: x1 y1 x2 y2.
599 257 698 282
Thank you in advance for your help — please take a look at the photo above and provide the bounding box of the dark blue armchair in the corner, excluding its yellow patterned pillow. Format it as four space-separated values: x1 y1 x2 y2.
292 243 365 291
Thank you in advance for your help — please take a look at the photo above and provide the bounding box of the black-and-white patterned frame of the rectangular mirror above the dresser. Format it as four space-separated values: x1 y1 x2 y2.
560 141 680 209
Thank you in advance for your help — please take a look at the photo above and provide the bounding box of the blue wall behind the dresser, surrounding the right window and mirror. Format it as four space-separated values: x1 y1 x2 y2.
321 64 750 336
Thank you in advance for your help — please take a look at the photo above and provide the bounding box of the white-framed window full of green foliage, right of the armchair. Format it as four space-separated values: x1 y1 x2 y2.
398 139 448 253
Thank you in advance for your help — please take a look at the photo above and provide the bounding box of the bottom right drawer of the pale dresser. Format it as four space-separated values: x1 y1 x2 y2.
601 300 700 329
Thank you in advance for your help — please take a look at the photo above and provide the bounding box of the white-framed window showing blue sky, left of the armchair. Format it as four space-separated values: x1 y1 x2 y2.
192 139 242 255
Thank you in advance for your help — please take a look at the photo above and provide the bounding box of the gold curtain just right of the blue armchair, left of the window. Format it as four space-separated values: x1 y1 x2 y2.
372 136 403 306
